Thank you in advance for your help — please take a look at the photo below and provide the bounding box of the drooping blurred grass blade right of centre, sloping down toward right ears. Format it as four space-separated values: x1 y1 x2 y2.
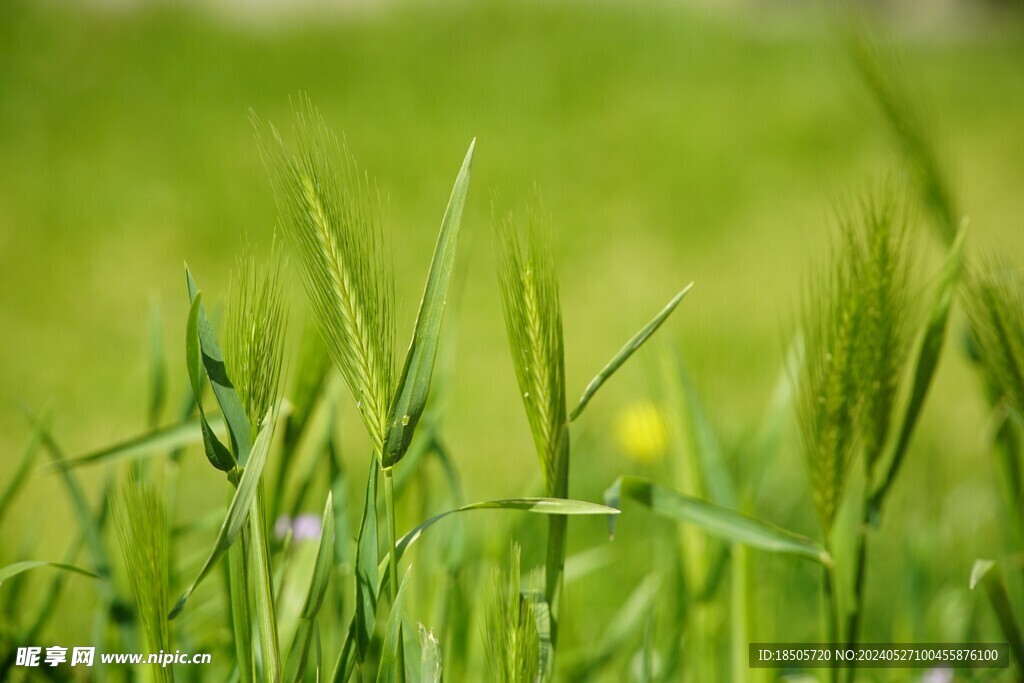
604 476 831 566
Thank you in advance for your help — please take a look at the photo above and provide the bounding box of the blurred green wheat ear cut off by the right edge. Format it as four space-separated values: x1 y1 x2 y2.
966 256 1024 417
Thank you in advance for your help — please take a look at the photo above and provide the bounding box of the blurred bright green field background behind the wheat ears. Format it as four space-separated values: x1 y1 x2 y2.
0 0 1024 675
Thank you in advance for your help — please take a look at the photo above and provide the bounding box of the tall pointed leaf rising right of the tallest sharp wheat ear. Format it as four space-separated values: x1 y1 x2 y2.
383 139 476 467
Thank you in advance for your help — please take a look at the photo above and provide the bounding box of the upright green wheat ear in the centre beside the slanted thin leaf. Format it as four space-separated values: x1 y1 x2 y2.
497 205 566 495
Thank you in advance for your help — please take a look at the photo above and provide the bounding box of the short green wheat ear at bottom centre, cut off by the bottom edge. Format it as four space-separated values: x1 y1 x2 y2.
484 544 541 683
